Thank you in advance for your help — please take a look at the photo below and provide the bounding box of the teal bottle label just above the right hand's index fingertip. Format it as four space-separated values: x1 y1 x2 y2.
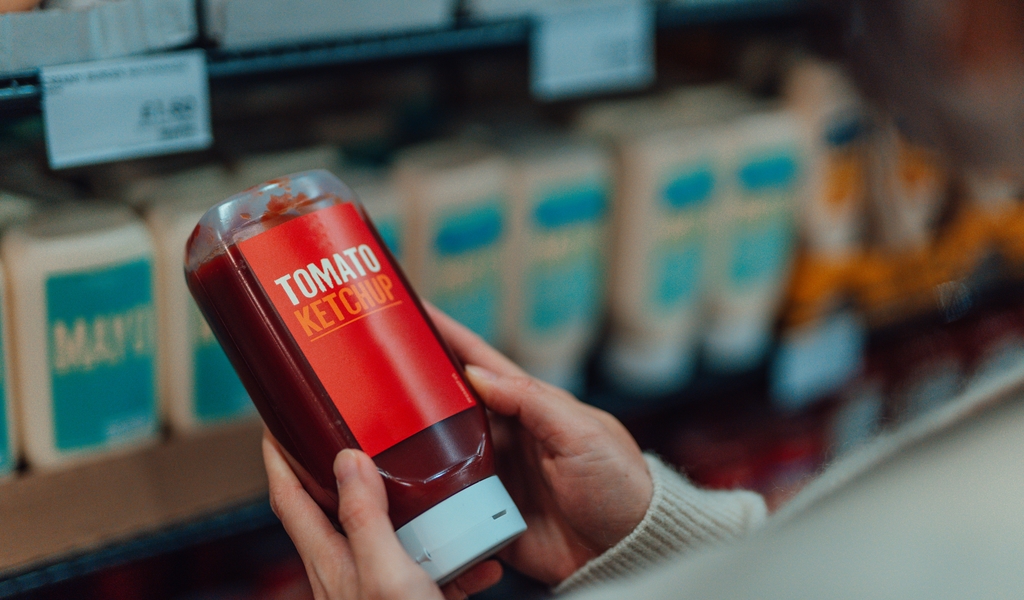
431 197 505 343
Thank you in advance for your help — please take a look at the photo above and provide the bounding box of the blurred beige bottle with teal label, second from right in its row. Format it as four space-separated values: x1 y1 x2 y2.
607 127 724 393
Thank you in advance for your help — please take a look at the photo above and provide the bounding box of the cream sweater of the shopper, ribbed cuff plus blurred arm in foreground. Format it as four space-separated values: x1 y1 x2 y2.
555 362 1024 600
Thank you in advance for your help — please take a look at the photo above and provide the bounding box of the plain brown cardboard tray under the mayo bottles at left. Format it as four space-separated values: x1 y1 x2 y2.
0 423 267 578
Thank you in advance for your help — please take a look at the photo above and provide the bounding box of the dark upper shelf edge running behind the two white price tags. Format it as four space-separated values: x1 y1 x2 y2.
0 0 806 115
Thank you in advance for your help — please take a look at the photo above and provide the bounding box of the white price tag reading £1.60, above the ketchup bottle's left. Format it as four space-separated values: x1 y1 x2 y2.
40 50 213 169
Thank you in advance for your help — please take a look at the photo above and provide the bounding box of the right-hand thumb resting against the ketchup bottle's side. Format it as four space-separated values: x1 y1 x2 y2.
466 365 593 453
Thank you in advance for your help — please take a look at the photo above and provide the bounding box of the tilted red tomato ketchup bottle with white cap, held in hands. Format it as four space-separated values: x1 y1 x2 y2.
185 171 526 583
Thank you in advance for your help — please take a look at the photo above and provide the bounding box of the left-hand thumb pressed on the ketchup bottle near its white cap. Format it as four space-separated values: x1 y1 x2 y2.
334 449 425 584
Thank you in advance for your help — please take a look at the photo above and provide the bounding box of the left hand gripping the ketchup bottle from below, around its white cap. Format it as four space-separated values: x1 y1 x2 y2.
263 429 502 600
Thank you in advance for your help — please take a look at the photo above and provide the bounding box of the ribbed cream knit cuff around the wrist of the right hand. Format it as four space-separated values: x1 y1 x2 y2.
555 454 767 594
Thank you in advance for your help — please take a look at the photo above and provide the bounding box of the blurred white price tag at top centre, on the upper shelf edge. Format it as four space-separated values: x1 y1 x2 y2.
530 0 654 99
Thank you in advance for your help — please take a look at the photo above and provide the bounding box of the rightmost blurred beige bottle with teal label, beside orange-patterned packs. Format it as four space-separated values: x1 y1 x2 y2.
705 109 807 372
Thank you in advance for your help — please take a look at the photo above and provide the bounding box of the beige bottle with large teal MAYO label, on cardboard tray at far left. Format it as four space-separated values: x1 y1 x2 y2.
0 205 159 469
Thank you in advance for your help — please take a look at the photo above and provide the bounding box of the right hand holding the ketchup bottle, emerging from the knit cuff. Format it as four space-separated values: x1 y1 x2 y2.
426 305 653 585
